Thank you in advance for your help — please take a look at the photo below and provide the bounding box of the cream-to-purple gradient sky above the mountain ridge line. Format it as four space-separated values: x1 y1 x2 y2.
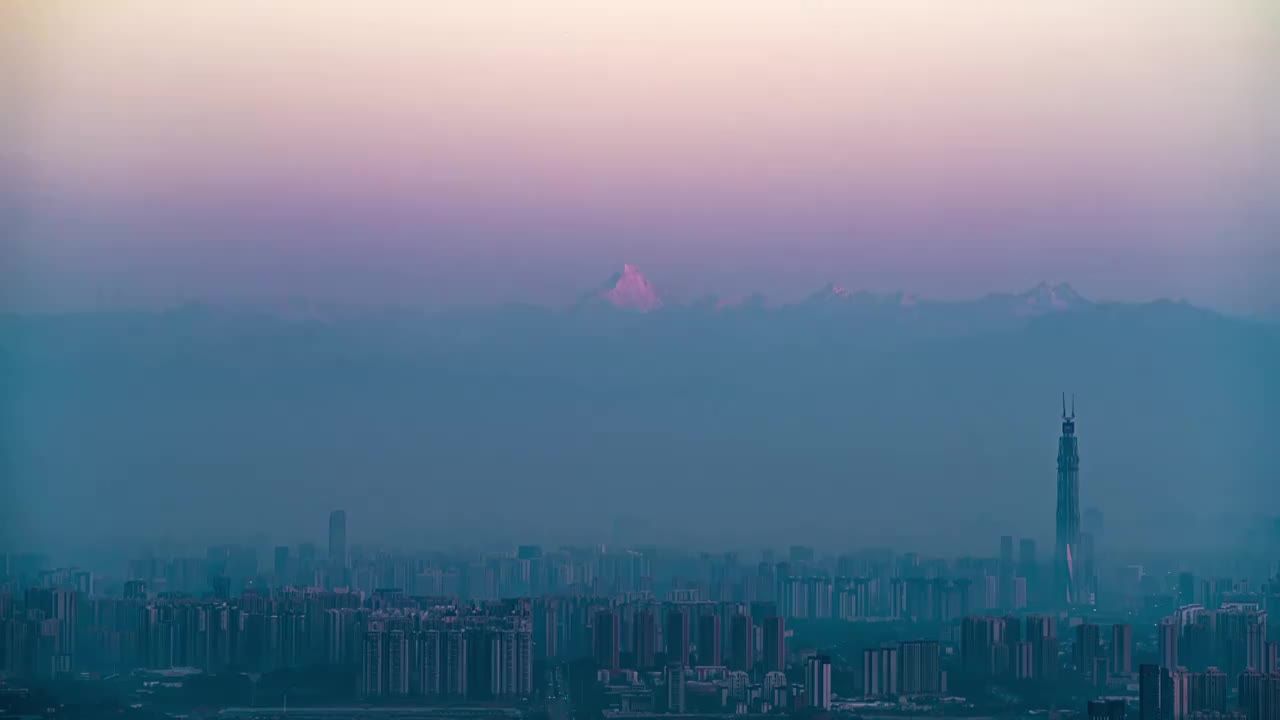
0 0 1280 310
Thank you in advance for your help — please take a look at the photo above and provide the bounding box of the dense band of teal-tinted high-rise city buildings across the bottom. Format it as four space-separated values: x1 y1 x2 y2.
0 510 1280 720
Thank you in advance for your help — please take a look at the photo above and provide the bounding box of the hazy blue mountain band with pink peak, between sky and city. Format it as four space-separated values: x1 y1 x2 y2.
0 269 1280 552
